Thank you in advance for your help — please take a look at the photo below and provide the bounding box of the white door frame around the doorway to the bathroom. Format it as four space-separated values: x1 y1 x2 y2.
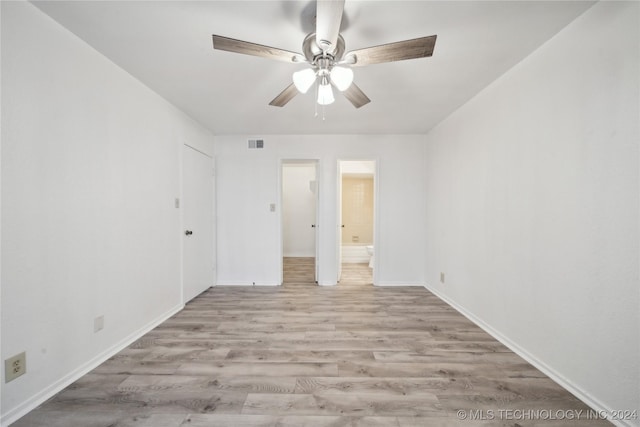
335 157 380 286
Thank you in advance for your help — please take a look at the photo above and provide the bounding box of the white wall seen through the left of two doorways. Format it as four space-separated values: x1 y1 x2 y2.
282 163 316 257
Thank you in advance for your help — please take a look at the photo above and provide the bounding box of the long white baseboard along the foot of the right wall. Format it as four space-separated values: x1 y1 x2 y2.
424 284 640 427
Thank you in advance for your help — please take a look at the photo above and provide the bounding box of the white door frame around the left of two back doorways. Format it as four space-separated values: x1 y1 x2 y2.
276 157 322 286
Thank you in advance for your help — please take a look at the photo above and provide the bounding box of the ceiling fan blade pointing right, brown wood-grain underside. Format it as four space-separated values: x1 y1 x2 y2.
345 36 437 67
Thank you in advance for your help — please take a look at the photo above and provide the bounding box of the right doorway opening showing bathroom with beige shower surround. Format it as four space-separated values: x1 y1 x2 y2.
337 160 377 285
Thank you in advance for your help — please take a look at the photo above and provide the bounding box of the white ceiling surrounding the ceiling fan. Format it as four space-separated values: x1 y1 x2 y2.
34 0 593 135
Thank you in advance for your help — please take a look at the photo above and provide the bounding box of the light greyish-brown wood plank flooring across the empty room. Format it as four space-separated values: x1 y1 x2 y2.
14 258 610 427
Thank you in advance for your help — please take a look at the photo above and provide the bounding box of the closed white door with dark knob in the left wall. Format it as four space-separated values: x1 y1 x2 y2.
182 145 215 303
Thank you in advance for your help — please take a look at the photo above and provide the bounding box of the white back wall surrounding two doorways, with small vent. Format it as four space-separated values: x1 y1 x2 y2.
215 135 424 285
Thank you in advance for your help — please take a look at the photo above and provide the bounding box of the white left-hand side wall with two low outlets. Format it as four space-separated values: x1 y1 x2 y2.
1 2 212 425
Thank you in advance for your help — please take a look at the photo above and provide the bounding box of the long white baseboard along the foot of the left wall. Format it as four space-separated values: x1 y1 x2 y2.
0 304 184 427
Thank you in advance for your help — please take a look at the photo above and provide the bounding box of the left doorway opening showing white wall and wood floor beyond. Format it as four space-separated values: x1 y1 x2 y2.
280 160 320 284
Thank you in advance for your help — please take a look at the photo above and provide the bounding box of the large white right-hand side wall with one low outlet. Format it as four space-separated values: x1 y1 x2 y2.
425 2 640 425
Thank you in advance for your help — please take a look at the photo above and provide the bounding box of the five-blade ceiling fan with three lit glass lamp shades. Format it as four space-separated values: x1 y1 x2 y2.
213 0 437 108
